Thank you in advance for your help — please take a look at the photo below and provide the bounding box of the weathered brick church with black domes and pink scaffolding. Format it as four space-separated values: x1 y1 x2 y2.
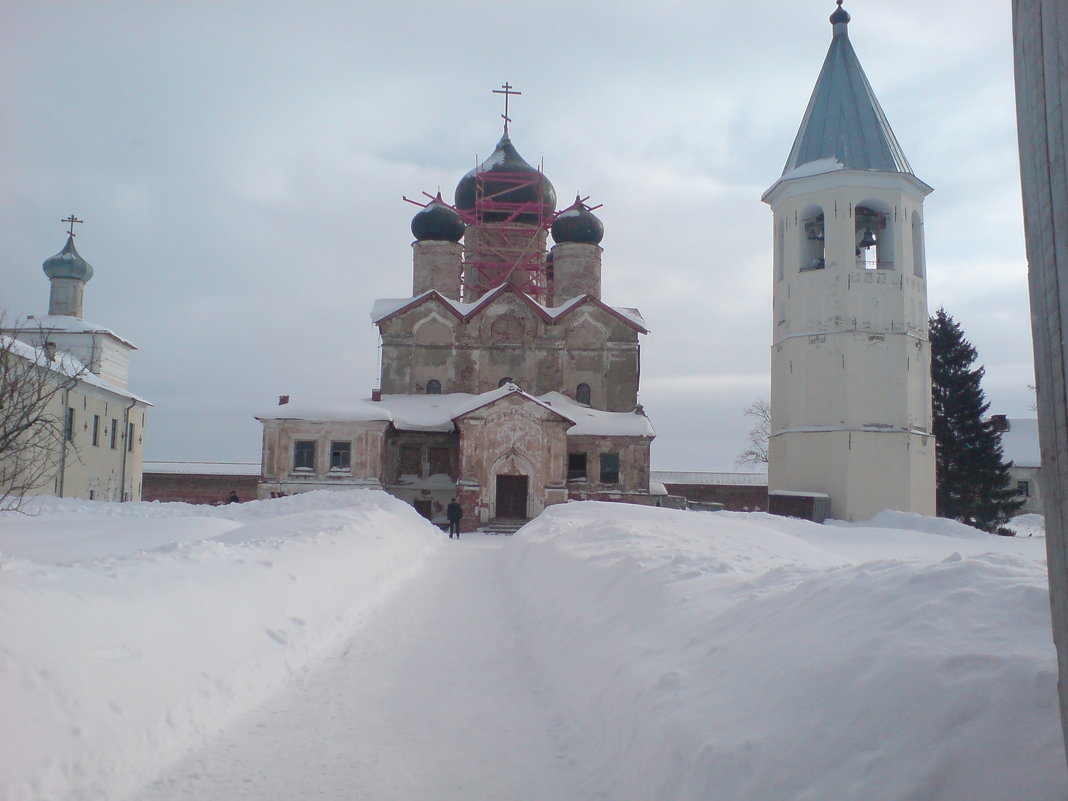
257 103 655 530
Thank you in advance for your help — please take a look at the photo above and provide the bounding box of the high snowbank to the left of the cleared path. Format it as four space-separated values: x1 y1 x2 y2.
0 491 441 800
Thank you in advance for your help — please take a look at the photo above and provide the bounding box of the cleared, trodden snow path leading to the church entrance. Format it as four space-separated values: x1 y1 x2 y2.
137 534 600 801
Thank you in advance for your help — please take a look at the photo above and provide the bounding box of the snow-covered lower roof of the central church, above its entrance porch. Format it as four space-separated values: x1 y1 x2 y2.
256 384 656 437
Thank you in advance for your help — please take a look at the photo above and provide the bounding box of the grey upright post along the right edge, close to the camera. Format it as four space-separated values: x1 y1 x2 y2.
1012 0 1068 768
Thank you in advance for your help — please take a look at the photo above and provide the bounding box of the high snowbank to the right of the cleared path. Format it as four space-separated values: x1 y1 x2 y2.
509 503 1068 801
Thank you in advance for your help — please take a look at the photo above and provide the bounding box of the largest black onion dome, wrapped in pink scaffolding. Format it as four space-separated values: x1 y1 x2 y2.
456 135 556 222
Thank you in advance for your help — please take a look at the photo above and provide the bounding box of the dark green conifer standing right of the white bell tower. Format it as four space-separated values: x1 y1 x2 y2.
930 309 1023 534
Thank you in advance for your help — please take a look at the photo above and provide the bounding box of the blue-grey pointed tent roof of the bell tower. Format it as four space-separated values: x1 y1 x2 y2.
782 0 913 178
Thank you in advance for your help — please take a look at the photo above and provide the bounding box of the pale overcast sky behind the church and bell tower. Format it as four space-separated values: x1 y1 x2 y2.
0 0 1034 470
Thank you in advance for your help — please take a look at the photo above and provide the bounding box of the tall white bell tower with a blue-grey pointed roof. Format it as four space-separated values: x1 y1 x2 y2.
763 0 935 520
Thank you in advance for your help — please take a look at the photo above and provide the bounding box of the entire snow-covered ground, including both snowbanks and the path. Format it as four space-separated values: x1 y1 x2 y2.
0 492 1068 801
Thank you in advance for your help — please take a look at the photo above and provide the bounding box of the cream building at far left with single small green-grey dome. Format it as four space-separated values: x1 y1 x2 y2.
0 228 150 501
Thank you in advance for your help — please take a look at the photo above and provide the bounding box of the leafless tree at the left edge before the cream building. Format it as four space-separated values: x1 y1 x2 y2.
0 315 88 511
